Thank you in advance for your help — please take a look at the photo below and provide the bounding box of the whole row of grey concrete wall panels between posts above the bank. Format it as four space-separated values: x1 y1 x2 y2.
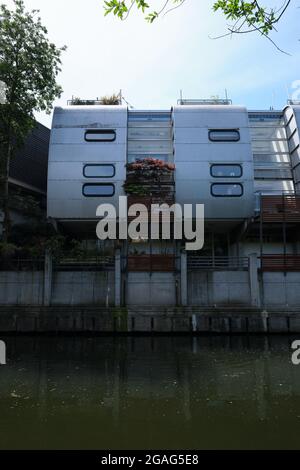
0 271 300 309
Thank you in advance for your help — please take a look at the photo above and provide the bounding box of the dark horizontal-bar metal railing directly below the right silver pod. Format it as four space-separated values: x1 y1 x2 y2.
187 255 249 271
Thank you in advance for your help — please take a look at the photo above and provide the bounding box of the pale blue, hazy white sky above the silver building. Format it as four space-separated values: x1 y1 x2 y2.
1 0 300 127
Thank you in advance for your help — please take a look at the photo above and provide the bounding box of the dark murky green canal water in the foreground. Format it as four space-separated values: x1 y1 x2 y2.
0 336 300 450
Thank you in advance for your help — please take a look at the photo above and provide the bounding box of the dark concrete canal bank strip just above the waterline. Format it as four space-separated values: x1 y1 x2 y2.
0 306 300 335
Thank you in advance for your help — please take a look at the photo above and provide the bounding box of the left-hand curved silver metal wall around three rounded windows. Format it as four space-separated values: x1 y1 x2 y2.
48 106 127 220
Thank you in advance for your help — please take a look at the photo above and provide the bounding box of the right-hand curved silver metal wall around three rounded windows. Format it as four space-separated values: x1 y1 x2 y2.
174 105 254 219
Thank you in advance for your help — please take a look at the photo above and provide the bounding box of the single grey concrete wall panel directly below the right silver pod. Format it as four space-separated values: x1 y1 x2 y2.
188 271 251 305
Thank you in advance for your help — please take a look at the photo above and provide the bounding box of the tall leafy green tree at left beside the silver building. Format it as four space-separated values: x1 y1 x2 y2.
0 0 65 240
